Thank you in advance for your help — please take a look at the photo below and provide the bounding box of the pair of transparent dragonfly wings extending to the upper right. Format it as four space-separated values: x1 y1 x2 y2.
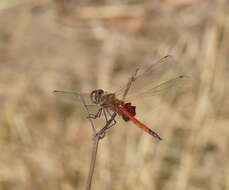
115 55 187 99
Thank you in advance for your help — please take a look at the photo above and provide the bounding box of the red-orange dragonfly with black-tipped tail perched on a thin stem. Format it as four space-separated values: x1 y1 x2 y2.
54 55 187 140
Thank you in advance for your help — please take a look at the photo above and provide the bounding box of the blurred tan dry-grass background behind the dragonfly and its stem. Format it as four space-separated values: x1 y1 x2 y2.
0 0 229 190
